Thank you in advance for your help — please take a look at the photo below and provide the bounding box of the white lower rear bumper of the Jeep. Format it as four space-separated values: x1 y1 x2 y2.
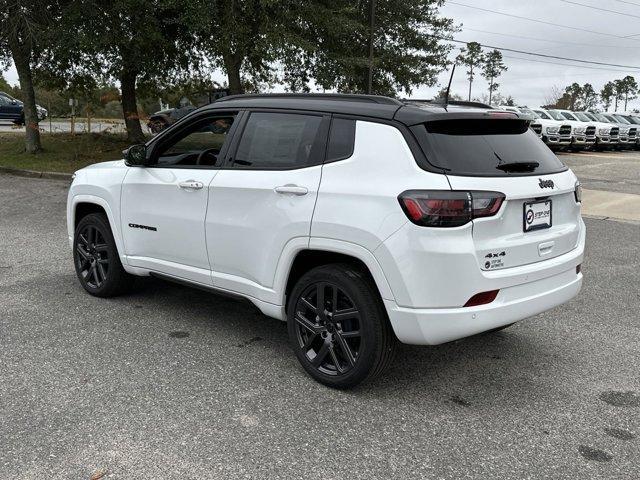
385 267 582 345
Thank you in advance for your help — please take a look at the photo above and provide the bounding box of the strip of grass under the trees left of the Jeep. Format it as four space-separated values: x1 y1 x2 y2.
0 133 129 173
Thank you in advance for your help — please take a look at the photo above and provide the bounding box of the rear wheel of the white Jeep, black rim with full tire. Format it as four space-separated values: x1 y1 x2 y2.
287 264 397 389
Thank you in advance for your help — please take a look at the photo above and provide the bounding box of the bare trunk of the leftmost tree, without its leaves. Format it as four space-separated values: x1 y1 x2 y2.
10 42 42 153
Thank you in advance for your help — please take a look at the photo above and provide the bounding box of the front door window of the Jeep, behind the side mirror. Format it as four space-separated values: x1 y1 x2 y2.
156 113 236 167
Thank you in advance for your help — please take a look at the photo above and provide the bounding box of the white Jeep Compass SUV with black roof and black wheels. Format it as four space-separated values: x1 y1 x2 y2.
67 94 585 388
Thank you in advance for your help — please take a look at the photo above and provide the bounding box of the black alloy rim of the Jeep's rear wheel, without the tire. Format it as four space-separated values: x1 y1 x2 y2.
295 282 362 375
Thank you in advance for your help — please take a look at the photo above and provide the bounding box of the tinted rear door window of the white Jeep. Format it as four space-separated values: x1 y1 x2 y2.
233 113 322 169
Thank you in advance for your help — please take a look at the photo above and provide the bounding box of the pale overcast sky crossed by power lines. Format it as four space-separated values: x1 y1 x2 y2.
4 0 640 110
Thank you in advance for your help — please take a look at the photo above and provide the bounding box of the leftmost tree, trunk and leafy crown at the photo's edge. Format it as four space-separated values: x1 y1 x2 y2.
0 0 62 153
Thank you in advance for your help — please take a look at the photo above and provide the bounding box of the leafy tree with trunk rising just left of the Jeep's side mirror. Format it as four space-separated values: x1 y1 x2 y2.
50 0 196 143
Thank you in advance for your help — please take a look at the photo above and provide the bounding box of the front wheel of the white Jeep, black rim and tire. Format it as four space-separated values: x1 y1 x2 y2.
73 213 134 298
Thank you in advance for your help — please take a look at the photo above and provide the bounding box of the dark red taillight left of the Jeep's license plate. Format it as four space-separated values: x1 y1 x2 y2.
398 190 505 227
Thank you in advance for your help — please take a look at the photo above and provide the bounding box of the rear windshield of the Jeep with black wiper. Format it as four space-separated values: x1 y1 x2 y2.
414 119 567 177
